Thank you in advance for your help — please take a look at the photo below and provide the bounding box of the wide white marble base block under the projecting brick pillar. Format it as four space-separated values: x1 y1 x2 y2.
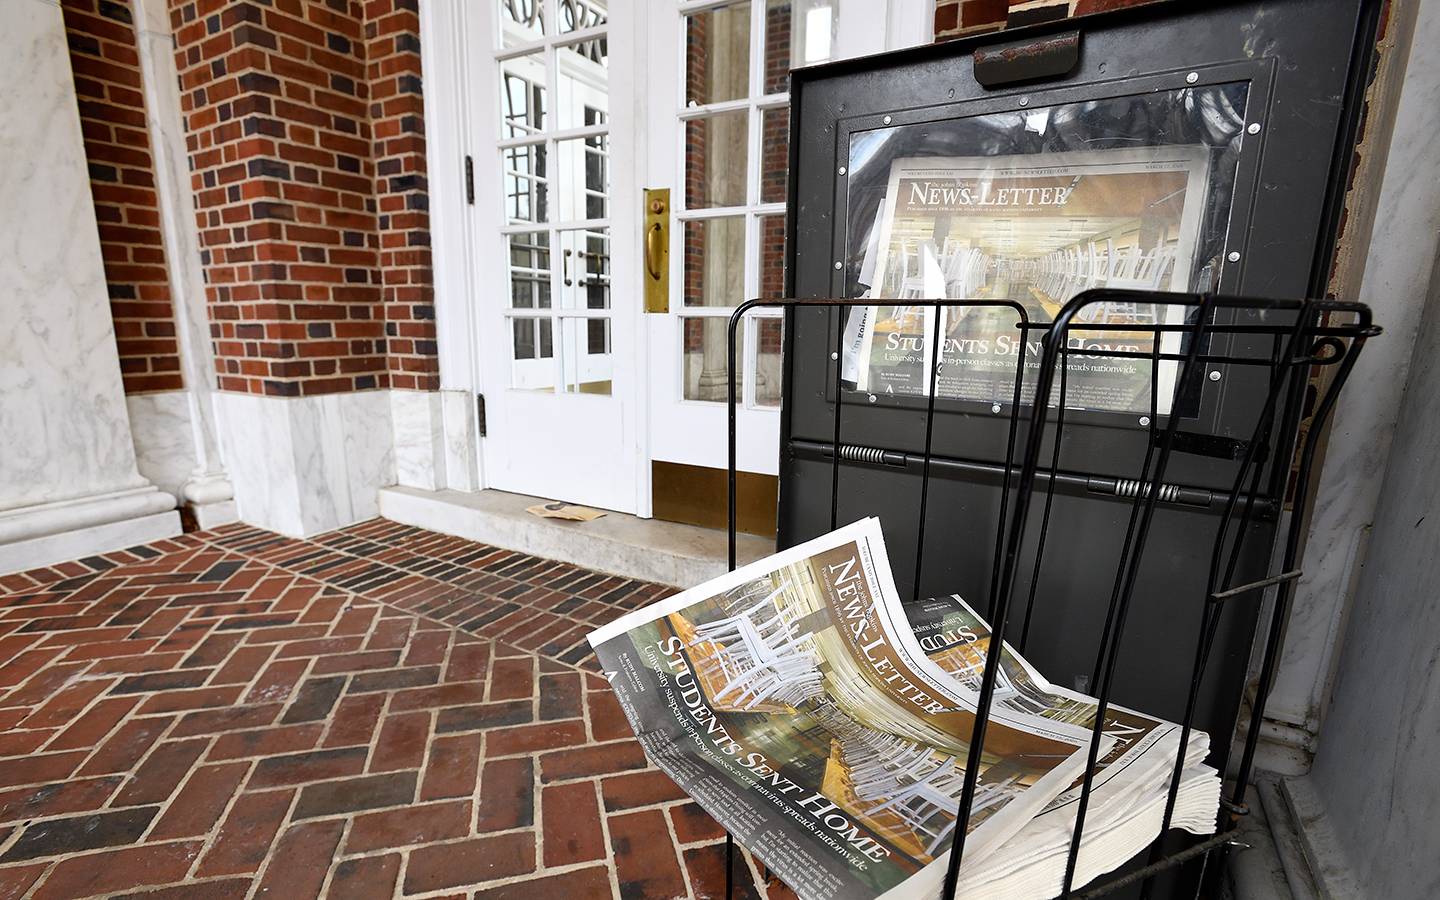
215 390 396 537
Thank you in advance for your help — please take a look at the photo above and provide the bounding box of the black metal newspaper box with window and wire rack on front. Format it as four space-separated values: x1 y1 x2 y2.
702 0 1381 897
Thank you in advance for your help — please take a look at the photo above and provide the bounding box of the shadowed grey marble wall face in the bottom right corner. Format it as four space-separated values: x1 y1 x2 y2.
1305 224 1440 899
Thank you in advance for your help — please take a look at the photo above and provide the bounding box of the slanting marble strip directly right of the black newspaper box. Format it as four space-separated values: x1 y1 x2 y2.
1266 4 1440 732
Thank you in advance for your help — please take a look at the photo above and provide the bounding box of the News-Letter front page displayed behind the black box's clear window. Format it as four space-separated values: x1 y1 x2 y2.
844 145 1210 415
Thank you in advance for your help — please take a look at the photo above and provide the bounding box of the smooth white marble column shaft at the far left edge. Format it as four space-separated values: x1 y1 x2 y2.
0 0 145 510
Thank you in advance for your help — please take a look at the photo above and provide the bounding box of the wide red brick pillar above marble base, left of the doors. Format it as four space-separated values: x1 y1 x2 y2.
170 0 438 396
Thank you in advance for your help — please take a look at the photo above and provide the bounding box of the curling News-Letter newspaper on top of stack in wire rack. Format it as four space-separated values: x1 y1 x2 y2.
590 518 1094 900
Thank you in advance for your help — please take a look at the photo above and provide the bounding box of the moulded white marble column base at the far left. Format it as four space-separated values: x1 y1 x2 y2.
0 487 180 573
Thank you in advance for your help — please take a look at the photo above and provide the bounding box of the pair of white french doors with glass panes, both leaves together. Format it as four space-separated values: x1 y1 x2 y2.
460 0 933 516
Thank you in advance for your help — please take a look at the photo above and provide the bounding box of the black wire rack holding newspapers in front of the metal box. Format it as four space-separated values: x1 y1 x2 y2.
726 289 1380 900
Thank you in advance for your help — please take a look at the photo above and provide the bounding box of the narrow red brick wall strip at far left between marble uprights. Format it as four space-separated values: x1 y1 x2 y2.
60 0 184 393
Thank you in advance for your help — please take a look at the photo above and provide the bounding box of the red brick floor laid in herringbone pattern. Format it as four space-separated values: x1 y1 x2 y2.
0 520 793 900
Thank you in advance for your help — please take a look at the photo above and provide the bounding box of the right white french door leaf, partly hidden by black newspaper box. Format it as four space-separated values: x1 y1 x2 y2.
642 0 933 492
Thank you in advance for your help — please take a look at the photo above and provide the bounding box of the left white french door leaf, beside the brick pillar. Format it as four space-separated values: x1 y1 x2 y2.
468 0 639 511
